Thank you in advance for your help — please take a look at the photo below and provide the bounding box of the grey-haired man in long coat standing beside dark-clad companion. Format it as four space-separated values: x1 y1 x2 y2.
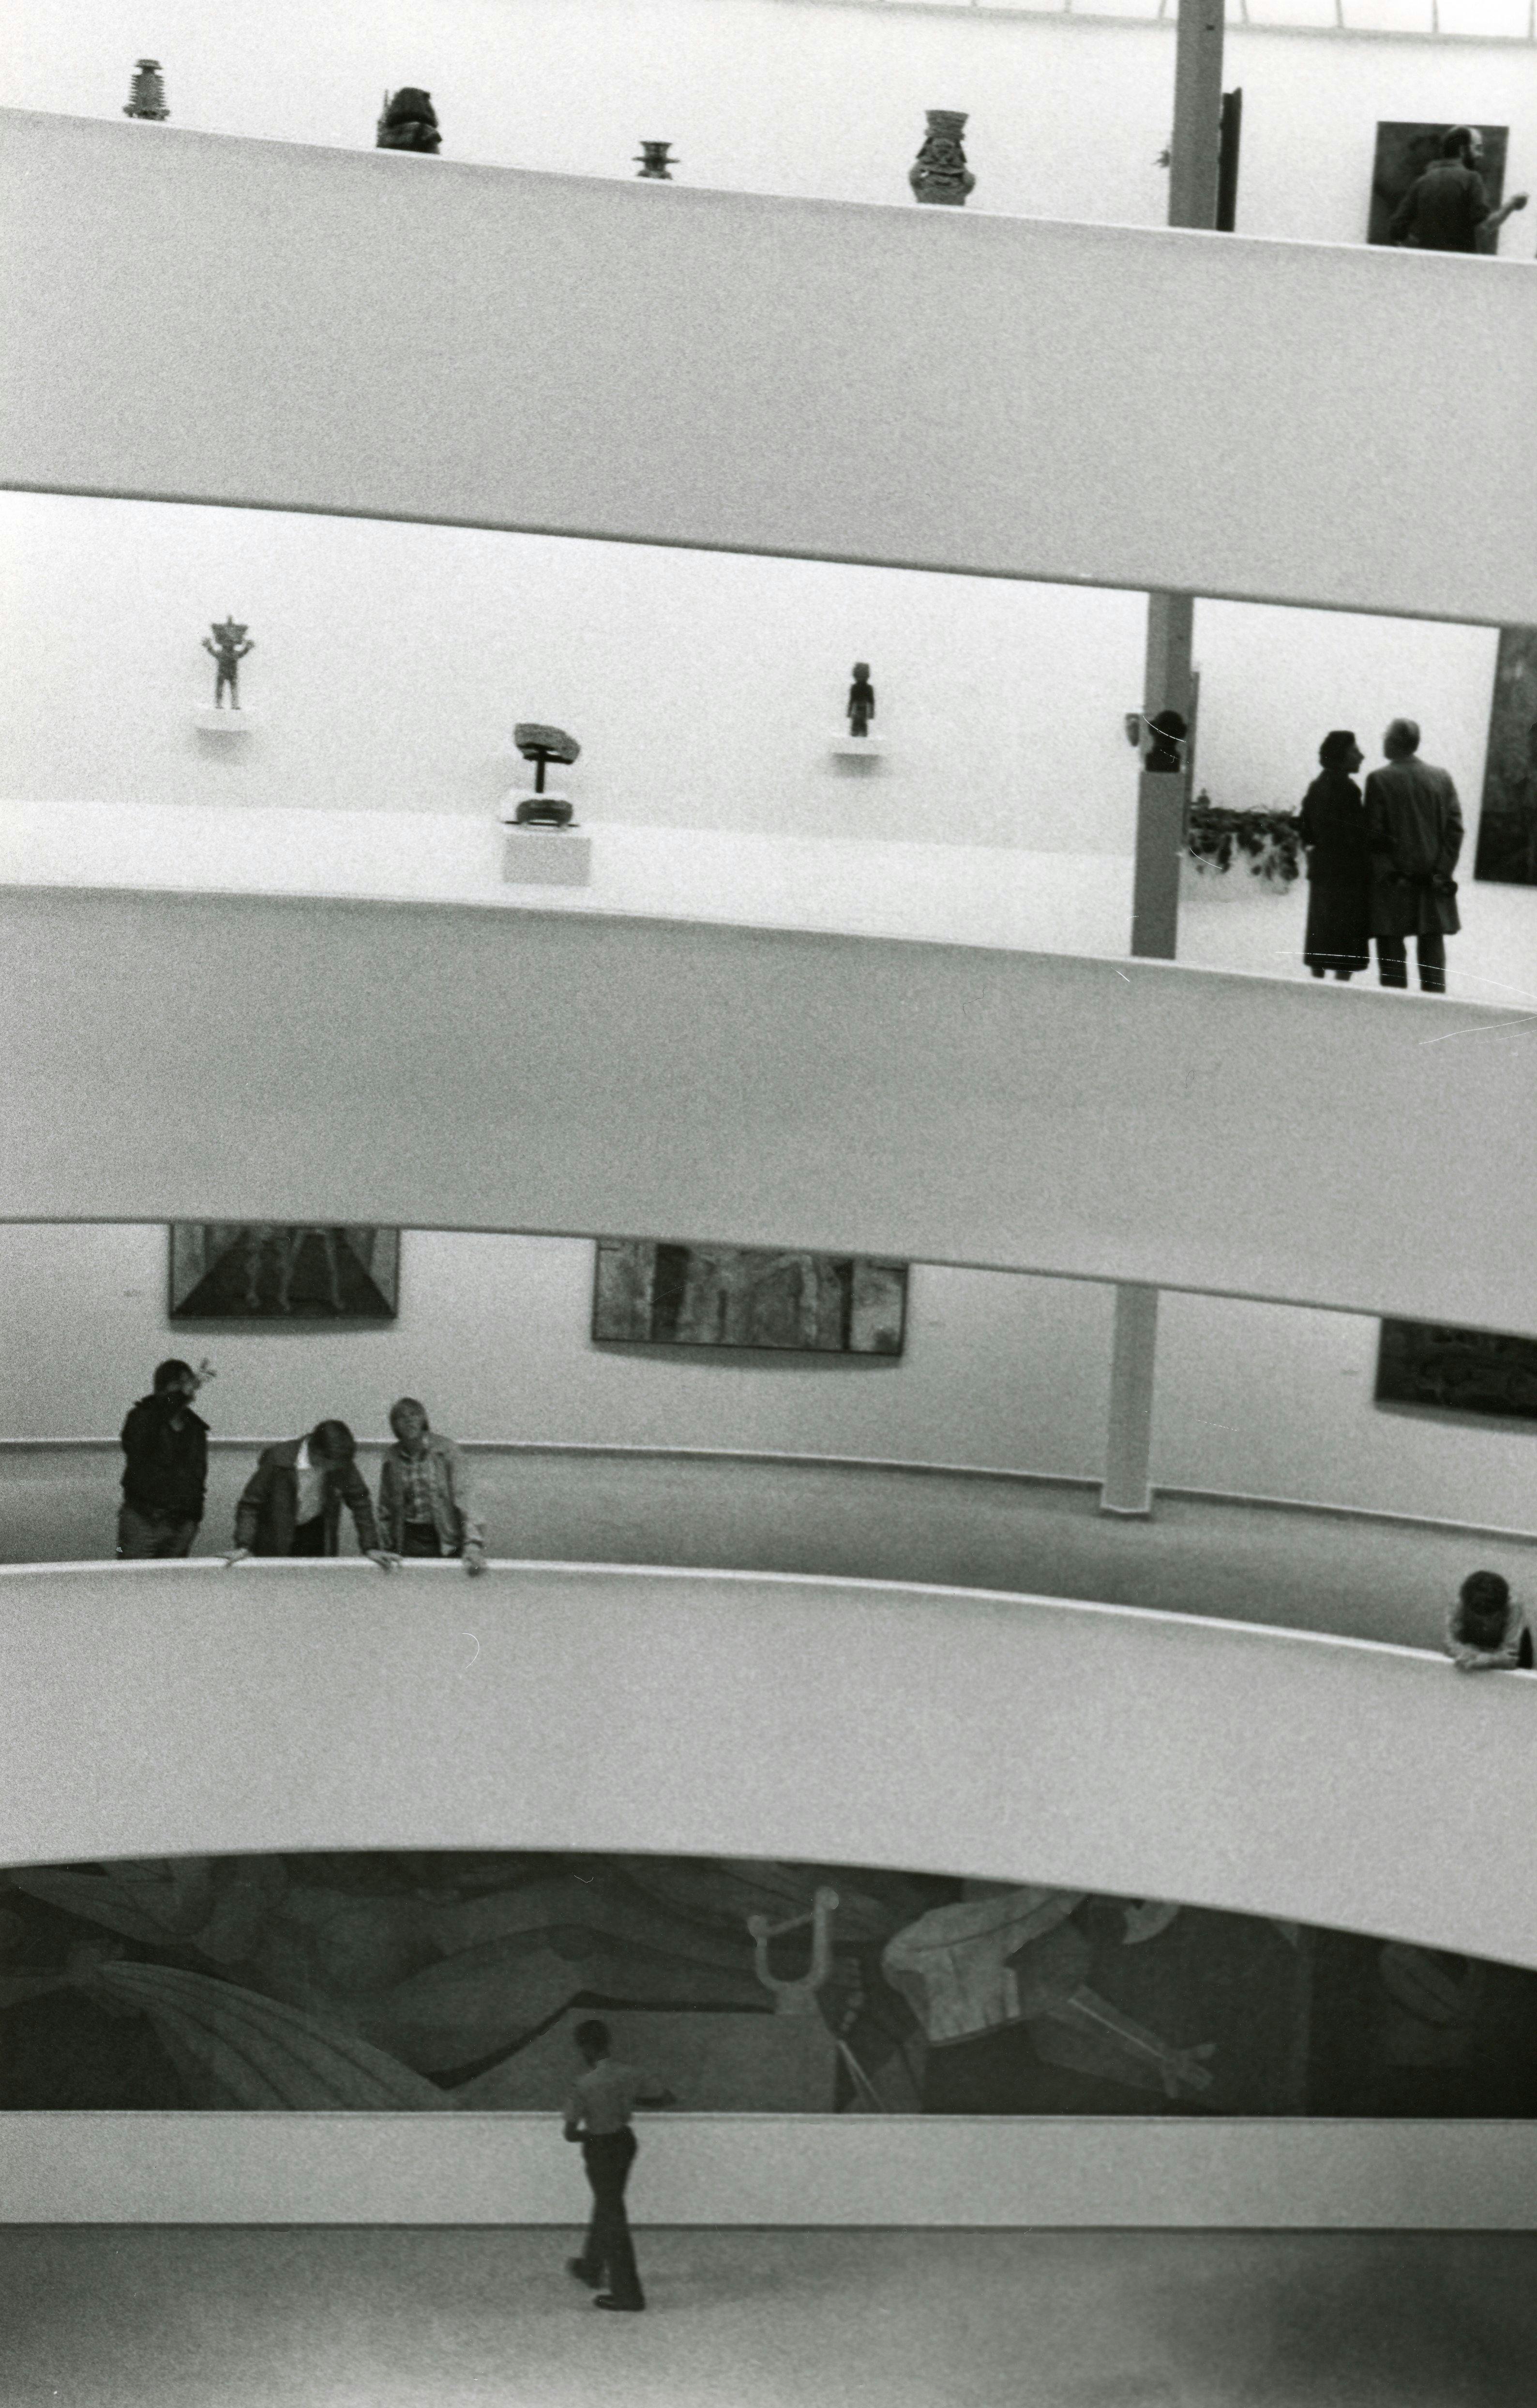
1366 720 1462 994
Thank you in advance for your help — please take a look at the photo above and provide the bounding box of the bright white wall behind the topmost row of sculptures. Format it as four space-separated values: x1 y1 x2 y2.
0 0 1537 244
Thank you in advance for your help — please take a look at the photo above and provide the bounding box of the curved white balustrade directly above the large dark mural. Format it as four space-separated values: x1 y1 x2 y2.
0 1560 1537 1965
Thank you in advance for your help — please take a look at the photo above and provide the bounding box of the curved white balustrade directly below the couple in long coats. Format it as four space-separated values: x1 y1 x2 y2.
0 891 1537 1332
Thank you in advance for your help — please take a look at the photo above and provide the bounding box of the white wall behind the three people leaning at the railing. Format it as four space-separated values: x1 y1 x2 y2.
0 1223 1537 1536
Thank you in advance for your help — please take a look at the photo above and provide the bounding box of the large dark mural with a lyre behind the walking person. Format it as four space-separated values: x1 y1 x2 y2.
0 1852 1537 2117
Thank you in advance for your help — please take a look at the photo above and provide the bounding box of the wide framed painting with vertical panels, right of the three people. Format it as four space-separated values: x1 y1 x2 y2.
593 1238 908 1355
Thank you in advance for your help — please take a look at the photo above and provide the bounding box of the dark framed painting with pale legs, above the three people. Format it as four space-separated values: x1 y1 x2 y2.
171 1221 400 1329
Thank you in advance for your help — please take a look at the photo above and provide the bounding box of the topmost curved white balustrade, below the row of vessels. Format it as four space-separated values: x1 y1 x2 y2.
0 111 1537 624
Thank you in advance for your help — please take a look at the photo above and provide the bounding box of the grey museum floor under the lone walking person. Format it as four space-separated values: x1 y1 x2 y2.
0 2225 1537 2408
